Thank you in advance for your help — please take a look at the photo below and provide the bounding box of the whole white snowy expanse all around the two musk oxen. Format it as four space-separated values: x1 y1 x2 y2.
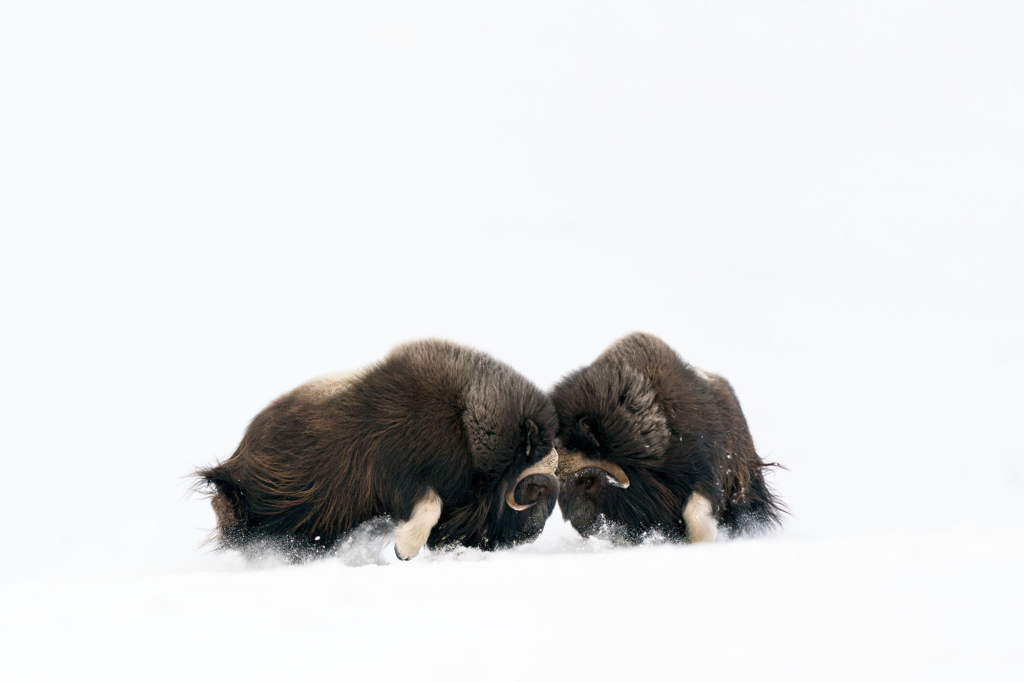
0 0 1024 680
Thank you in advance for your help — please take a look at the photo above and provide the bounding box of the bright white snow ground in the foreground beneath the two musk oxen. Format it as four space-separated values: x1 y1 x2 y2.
4 520 1024 680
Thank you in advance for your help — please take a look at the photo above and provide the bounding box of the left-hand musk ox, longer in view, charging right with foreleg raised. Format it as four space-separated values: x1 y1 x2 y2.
197 340 558 559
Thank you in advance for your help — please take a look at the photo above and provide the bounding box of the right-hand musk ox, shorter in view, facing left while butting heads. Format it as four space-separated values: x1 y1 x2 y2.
550 334 784 542
